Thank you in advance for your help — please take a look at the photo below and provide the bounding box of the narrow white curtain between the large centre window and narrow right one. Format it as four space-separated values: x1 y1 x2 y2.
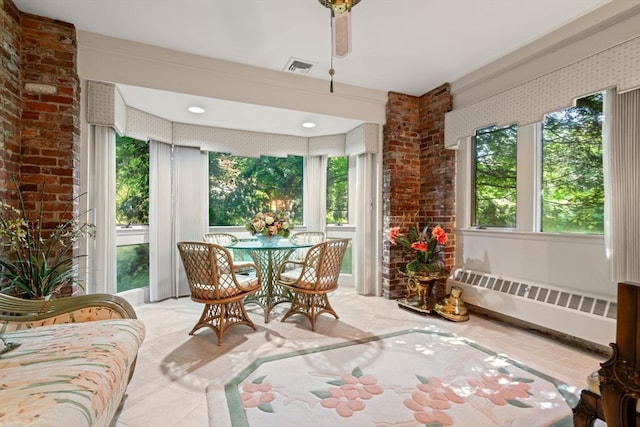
303 156 327 232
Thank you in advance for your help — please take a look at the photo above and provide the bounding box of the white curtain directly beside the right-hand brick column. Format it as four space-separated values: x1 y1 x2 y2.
350 153 382 296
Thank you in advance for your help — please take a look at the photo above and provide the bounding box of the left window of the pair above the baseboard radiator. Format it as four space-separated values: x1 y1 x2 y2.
472 125 517 227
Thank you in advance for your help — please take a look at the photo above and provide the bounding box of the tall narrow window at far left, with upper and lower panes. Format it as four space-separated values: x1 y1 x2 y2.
116 135 149 292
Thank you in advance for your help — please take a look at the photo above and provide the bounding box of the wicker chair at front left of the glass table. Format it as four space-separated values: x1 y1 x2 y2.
178 242 262 345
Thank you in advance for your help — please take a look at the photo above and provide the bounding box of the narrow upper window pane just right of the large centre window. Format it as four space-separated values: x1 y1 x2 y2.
326 156 349 224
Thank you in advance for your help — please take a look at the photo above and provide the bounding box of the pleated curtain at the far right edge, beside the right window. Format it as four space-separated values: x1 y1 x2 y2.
605 89 640 283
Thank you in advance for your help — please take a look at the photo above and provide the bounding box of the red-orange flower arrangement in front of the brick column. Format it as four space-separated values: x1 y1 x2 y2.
389 222 447 277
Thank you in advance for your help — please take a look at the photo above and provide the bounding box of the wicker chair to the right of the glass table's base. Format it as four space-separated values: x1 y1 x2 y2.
277 239 349 331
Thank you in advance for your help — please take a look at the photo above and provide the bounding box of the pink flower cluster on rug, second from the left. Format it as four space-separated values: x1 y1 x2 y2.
311 368 384 418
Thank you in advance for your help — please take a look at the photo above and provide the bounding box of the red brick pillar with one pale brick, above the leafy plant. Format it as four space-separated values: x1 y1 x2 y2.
20 14 80 223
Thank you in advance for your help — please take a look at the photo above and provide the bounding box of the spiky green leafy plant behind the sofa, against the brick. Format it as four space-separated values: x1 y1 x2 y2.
0 178 95 298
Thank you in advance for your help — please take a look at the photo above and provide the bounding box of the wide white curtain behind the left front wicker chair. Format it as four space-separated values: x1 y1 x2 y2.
149 141 209 301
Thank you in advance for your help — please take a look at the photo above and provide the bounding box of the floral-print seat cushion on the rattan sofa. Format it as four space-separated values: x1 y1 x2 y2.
0 319 145 426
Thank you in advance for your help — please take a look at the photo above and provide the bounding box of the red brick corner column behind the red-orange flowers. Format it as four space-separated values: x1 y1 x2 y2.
382 84 455 299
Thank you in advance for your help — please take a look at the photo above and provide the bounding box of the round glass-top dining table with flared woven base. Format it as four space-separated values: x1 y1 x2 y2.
225 239 313 323
